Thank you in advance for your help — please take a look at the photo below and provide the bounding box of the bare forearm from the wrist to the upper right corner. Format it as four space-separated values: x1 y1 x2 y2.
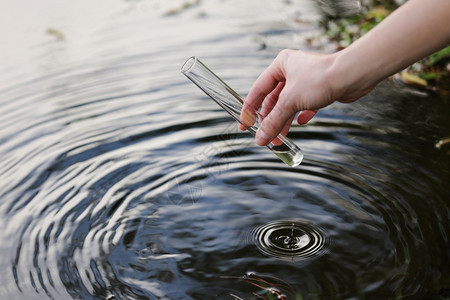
333 0 450 101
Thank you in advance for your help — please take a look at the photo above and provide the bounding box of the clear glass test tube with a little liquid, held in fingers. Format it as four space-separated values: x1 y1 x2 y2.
181 56 303 167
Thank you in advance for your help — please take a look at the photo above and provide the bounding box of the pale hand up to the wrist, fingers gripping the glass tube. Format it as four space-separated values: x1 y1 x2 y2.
241 50 367 146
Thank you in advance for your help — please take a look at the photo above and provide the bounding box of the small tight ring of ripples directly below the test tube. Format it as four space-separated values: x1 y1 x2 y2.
253 220 327 261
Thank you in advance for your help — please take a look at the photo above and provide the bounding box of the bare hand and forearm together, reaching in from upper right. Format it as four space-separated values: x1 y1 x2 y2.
241 0 450 146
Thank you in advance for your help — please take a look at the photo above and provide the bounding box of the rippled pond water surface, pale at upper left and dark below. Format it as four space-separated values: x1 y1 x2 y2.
0 1 450 300
